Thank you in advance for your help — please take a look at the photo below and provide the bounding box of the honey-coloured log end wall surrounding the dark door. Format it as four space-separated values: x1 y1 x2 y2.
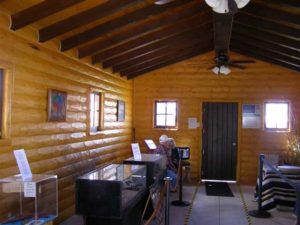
133 52 300 184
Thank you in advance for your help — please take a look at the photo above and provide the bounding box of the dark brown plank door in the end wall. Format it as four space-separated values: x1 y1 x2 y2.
202 102 238 180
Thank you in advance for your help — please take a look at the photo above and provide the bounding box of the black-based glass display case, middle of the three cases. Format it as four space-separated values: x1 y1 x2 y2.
76 164 146 219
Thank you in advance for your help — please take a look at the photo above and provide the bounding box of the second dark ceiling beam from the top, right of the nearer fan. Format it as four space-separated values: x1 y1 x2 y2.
234 12 300 38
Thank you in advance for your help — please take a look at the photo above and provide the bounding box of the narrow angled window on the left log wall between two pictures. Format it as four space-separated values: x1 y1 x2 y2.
90 91 103 132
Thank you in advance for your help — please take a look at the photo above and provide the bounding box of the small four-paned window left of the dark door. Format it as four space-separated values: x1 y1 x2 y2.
154 101 177 128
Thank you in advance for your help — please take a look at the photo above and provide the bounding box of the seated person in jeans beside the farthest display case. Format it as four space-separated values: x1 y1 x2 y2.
155 134 177 192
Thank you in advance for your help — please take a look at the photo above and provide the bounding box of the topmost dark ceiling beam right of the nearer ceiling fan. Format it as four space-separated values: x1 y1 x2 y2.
241 1 300 25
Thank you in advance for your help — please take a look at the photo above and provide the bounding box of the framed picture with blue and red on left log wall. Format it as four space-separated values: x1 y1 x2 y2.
48 89 67 122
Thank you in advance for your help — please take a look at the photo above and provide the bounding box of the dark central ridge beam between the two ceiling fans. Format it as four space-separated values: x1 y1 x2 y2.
213 12 234 55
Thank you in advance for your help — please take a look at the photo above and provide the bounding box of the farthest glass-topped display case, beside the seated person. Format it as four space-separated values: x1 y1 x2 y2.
123 154 166 187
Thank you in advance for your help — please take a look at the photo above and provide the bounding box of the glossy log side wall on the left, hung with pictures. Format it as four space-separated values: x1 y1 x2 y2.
0 11 133 221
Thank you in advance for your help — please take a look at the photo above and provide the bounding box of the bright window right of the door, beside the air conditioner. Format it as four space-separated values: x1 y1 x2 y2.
265 102 289 131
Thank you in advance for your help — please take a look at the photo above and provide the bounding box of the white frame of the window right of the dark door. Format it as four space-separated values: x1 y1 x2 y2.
264 100 291 132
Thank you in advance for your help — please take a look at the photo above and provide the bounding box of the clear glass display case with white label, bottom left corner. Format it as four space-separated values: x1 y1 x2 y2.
0 174 58 225
